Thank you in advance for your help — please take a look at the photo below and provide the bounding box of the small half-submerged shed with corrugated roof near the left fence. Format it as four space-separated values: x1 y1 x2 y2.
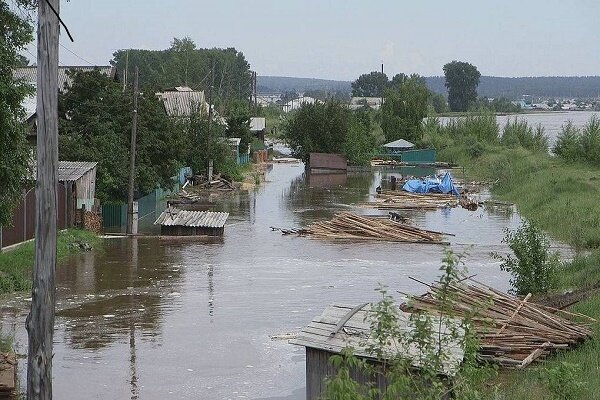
154 207 229 236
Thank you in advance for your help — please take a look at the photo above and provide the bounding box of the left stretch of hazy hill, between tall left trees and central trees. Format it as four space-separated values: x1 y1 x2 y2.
256 75 352 93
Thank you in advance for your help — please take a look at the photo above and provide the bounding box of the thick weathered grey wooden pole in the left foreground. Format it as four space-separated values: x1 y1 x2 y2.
26 0 60 400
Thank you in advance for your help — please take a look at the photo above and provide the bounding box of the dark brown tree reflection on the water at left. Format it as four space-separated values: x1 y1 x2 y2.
56 238 183 349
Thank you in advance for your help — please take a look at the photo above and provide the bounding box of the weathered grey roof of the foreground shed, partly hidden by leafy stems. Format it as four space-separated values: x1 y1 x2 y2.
290 303 464 376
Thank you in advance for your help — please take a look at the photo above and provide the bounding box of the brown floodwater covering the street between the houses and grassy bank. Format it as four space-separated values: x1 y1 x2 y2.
1 164 564 400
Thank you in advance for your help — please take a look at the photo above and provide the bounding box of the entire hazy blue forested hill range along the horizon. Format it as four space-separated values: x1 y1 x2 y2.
257 75 600 100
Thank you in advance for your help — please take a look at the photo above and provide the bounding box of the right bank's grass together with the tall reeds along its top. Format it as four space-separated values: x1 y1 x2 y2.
424 112 600 399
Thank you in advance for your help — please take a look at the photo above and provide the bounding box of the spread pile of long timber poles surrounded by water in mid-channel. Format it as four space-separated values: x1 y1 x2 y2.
301 212 446 244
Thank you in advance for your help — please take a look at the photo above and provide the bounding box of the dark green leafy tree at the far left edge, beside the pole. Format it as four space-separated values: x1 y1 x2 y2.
0 0 33 225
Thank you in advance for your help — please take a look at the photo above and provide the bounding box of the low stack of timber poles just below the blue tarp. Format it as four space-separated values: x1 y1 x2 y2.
361 191 458 210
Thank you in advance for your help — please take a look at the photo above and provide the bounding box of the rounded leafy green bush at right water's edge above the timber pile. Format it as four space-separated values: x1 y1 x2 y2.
492 221 560 295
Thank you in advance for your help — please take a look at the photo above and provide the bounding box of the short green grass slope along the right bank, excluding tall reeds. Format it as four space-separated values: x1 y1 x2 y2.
432 132 600 400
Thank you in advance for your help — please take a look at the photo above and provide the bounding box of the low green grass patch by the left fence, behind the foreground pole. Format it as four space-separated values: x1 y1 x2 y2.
0 229 99 294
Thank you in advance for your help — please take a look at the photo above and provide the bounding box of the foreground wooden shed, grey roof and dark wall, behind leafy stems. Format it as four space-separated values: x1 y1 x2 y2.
290 303 464 400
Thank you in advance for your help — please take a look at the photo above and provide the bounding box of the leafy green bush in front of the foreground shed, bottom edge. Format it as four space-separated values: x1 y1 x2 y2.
323 251 496 400
